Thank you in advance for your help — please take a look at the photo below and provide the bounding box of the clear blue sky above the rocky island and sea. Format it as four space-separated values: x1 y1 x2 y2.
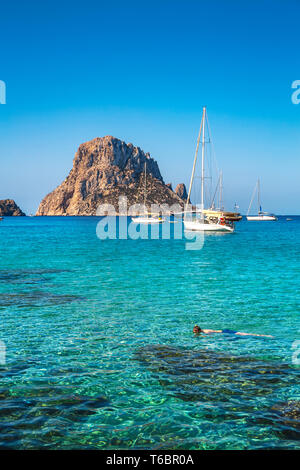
0 0 300 214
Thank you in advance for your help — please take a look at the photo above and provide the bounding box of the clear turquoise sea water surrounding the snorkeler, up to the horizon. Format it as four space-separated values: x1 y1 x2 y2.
0 217 300 449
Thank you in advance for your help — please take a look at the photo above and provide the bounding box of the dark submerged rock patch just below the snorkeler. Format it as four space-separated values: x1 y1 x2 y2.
136 345 300 403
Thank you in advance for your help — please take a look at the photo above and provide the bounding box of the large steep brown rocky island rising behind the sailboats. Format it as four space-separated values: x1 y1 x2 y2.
36 136 183 215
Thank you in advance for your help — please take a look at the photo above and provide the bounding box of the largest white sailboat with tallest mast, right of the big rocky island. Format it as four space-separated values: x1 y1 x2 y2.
183 107 239 233
